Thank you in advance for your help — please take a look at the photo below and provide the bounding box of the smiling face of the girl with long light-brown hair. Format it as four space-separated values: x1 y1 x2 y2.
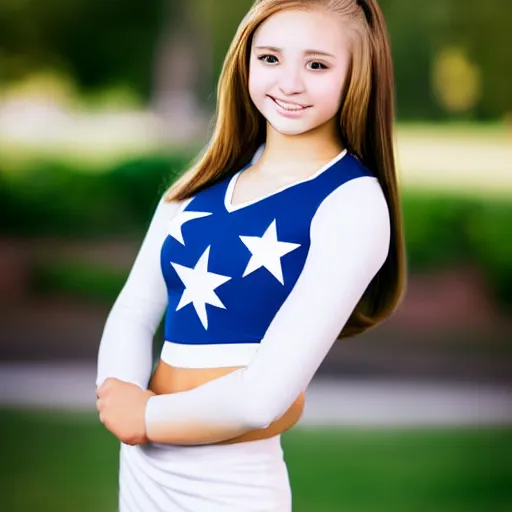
249 10 350 135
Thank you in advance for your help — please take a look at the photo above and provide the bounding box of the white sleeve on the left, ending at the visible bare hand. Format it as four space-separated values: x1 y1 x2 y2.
96 197 180 389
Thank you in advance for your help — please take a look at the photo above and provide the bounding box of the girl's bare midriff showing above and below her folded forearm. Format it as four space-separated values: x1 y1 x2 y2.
149 360 305 444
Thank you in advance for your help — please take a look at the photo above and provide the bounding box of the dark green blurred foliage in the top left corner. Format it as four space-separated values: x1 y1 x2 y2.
0 0 165 96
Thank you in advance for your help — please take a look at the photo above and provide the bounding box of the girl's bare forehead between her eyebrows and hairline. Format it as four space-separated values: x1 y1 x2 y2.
253 9 346 53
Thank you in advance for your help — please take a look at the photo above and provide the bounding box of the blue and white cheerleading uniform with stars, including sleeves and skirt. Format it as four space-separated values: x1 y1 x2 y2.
97 146 390 512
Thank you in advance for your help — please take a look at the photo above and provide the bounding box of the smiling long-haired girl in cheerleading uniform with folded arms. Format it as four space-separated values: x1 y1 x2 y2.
97 0 405 512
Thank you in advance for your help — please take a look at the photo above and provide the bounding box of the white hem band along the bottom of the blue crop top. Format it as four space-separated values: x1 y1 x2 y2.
160 340 259 368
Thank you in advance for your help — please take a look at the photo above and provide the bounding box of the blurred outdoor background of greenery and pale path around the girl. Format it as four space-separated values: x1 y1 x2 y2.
0 0 512 512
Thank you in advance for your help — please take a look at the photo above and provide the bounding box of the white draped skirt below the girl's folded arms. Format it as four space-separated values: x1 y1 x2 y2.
119 436 292 512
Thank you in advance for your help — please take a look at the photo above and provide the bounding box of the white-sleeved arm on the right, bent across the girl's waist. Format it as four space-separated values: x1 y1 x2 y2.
145 178 390 445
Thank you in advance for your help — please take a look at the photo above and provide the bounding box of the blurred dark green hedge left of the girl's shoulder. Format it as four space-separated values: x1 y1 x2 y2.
0 151 189 237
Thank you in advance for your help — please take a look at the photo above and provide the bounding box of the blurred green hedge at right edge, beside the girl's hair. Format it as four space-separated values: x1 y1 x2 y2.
402 191 512 306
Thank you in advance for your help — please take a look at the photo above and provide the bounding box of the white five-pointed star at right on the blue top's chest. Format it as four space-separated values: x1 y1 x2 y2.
240 219 300 284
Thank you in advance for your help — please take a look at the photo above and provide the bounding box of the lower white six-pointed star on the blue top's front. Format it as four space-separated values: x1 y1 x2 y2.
170 246 231 329
